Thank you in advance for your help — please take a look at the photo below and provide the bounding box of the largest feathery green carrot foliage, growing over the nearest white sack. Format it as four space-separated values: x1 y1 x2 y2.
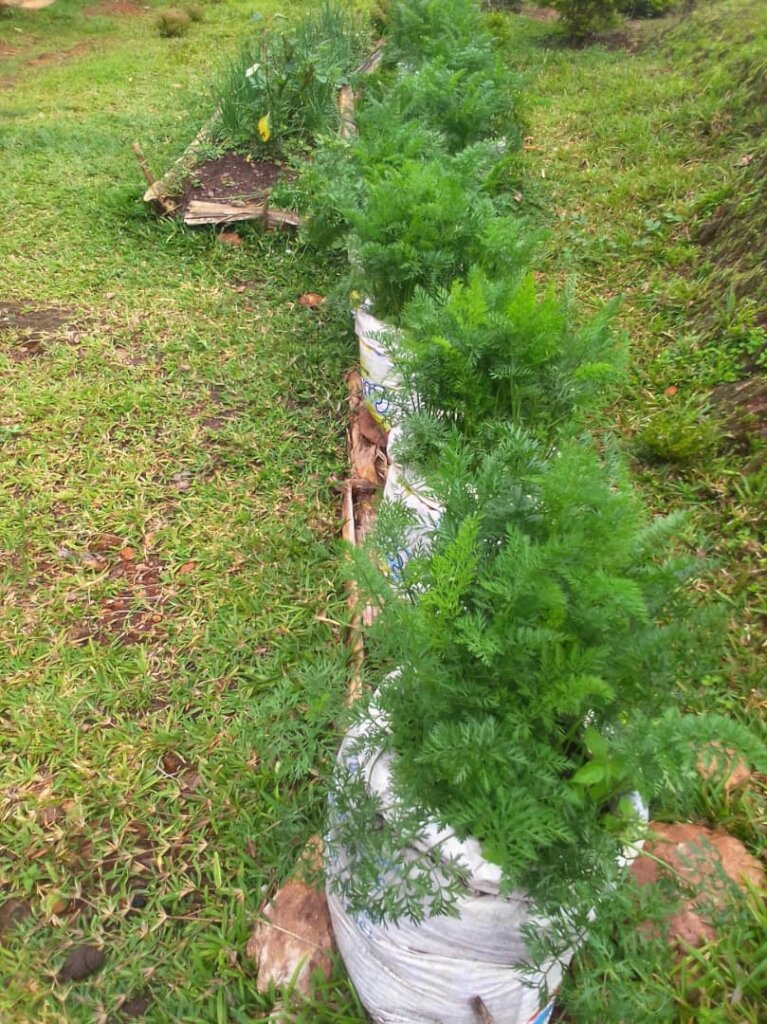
336 427 764 925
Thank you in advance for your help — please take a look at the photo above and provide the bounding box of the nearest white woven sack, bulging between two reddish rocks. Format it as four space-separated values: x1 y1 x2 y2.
328 712 569 1024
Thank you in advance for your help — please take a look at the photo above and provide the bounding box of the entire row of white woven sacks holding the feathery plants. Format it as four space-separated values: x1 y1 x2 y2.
328 307 566 1024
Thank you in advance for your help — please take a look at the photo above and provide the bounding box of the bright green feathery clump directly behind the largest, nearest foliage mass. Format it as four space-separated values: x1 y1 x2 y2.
393 264 626 444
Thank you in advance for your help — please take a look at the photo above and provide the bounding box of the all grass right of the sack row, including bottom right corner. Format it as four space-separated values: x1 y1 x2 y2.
499 0 767 1024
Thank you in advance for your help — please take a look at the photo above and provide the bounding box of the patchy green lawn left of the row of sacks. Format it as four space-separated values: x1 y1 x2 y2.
0 0 364 1024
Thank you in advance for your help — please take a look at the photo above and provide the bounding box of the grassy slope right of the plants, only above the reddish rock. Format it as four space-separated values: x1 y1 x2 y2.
507 0 767 717
